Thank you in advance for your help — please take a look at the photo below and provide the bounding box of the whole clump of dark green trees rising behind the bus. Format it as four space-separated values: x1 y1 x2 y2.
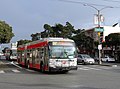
31 22 94 55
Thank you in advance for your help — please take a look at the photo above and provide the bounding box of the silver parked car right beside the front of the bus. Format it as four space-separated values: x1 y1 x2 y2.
77 54 95 64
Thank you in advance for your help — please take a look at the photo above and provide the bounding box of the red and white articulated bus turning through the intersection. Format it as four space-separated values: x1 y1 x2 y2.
17 38 77 73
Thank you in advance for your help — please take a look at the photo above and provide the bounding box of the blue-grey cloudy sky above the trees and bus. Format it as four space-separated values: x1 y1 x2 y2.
0 0 120 42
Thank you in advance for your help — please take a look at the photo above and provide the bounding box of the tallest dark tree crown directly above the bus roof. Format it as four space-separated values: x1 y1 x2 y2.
41 22 75 38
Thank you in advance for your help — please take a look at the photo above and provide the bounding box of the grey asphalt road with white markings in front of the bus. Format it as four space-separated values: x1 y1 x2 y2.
0 60 120 89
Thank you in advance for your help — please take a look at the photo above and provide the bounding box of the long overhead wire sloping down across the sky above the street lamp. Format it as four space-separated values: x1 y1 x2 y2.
58 0 120 8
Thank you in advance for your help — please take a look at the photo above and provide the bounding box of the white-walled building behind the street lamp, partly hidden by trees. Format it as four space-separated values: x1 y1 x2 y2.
85 25 120 61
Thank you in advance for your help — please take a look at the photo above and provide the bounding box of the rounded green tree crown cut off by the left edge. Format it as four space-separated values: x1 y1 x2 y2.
0 21 14 43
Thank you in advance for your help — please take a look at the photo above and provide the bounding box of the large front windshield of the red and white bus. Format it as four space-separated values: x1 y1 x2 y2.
50 45 76 59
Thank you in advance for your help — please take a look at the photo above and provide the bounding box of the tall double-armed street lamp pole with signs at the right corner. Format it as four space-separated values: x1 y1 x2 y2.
84 4 113 64
